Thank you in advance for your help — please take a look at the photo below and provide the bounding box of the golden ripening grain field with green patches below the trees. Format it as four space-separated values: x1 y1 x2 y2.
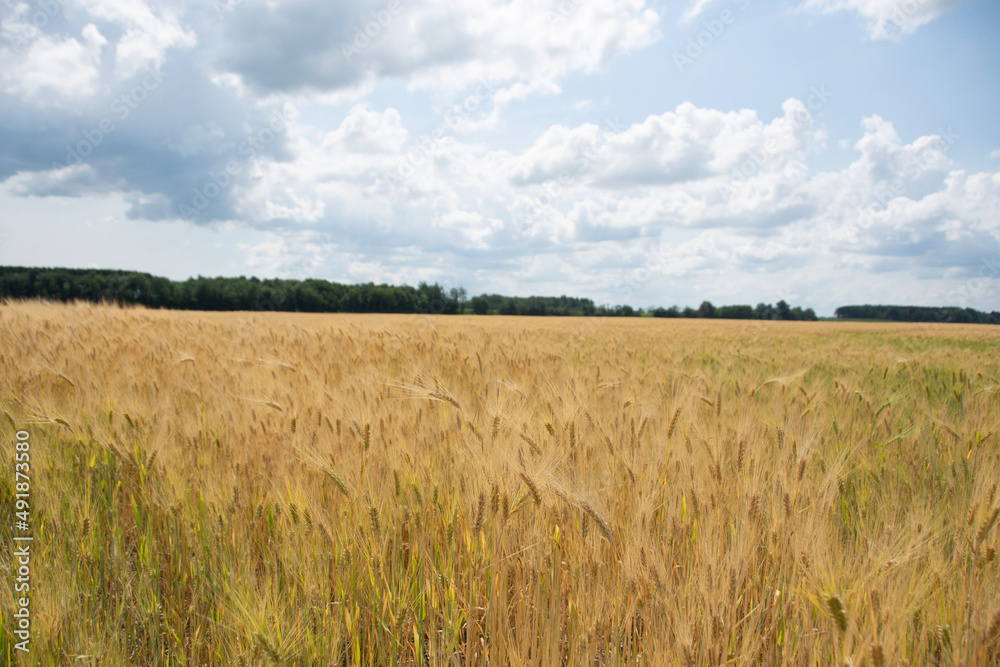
0 302 1000 666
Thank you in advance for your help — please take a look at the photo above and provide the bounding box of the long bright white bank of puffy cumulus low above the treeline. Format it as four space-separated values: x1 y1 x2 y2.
174 93 1000 305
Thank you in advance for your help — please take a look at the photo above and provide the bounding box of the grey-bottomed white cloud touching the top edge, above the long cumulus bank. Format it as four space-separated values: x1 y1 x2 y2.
220 0 659 101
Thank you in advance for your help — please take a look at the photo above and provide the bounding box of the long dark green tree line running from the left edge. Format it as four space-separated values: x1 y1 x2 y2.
0 266 816 320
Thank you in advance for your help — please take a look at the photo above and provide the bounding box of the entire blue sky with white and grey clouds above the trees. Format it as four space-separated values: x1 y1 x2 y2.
0 0 1000 316
